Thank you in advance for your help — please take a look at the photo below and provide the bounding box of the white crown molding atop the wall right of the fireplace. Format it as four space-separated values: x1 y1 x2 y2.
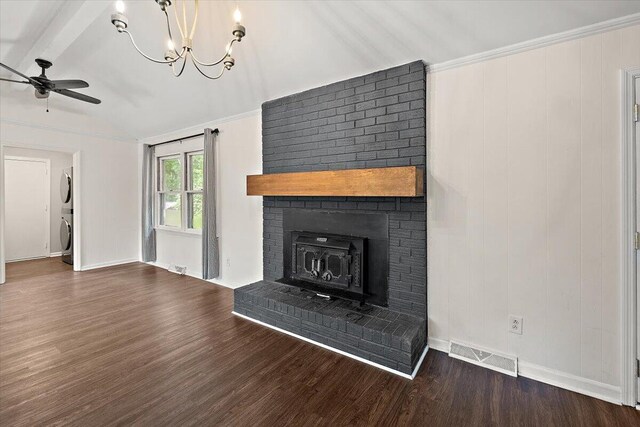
428 13 640 73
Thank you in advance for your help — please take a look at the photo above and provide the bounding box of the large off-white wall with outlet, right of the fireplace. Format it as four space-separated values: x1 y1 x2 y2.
427 25 640 395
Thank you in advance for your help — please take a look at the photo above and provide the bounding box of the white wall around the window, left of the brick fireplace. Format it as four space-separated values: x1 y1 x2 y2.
143 112 262 288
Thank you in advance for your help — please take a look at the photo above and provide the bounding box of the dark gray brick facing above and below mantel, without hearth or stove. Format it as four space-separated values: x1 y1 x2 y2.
262 61 427 319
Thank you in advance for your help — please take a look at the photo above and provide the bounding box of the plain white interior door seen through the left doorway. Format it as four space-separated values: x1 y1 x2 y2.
4 158 49 261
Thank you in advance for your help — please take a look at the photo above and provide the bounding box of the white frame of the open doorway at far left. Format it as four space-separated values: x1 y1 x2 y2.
0 147 82 285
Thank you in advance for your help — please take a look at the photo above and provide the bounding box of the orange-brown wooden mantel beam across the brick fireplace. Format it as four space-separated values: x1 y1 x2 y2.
247 166 424 197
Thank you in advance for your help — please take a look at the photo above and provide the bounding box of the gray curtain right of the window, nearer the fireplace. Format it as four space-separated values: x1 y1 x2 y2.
202 129 220 279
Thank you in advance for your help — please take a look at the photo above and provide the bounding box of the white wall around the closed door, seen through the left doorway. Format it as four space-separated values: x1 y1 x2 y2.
4 147 73 254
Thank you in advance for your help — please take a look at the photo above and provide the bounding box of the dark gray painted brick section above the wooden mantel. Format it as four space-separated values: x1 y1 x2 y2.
262 61 426 173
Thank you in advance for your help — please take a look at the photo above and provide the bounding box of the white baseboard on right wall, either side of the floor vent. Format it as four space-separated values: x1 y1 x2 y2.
428 337 622 405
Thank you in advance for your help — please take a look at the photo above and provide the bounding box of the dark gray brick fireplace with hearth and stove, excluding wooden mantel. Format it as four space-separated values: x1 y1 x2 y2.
234 61 427 374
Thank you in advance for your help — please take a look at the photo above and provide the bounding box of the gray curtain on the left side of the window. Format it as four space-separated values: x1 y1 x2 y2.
142 145 156 262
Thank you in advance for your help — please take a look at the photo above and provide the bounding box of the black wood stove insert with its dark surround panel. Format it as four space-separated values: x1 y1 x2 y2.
278 209 389 307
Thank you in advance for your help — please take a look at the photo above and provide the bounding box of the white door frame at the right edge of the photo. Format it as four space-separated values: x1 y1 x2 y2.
620 67 640 406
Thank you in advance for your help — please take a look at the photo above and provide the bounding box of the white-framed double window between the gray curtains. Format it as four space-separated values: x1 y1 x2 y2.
156 151 204 231
